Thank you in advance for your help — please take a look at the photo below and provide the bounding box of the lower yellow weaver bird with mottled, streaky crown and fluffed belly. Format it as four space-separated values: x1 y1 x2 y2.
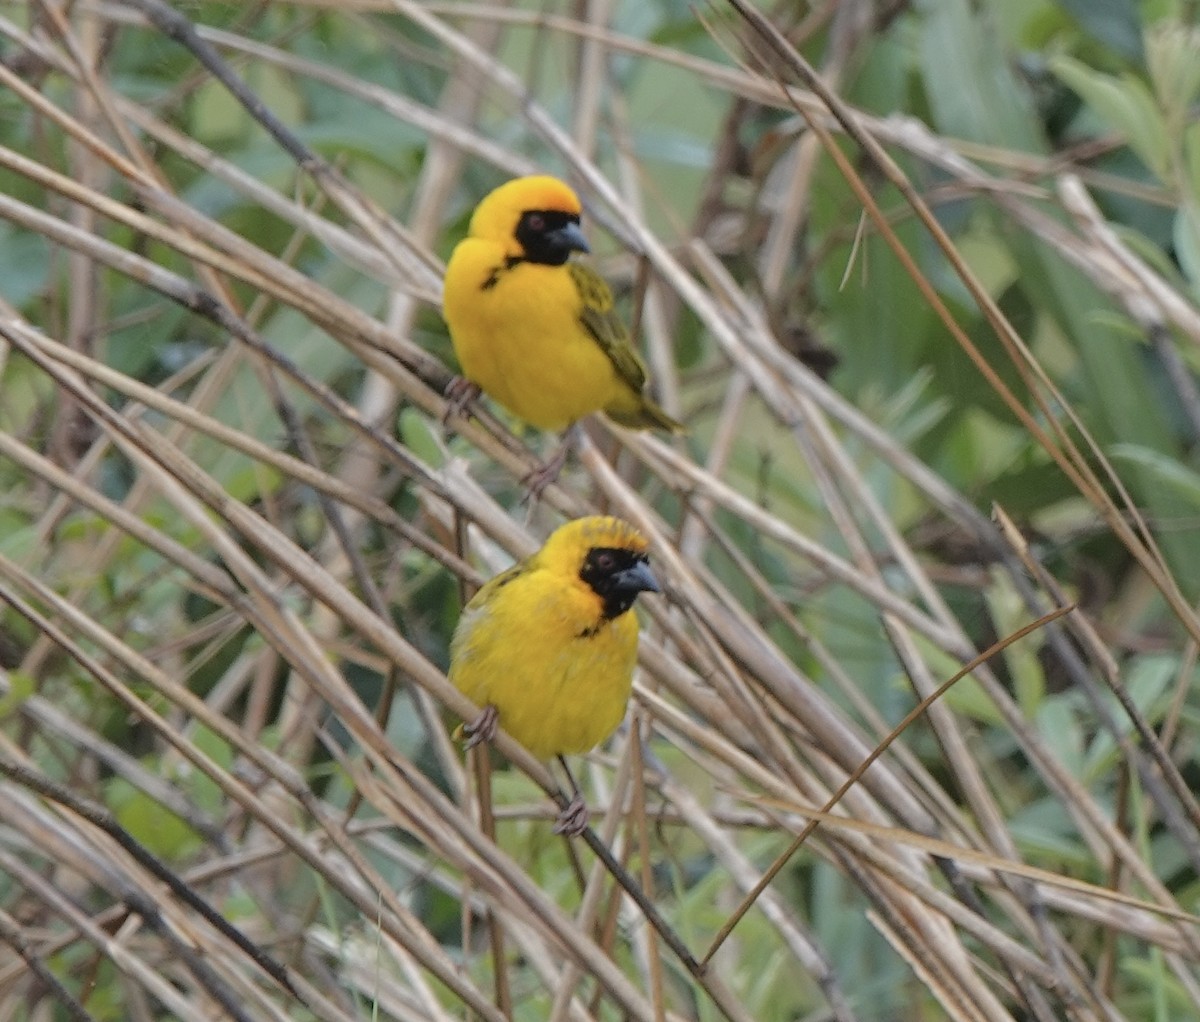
449 517 660 836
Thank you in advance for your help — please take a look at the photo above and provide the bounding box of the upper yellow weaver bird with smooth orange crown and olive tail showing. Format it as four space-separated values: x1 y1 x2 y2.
443 175 683 485
